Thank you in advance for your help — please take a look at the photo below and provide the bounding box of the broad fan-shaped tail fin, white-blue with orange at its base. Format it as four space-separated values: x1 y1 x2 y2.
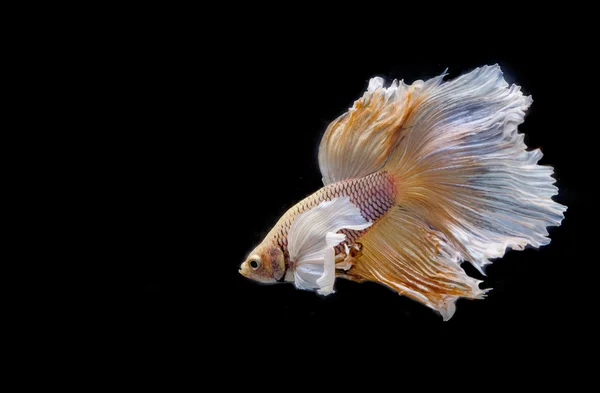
384 66 566 272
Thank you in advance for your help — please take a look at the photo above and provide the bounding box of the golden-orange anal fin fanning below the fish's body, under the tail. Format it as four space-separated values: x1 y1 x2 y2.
339 207 486 320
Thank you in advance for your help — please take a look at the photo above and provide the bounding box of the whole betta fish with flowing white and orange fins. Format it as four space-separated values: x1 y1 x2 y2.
240 65 566 320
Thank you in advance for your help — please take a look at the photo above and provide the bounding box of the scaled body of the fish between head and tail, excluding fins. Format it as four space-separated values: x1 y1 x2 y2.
267 172 395 264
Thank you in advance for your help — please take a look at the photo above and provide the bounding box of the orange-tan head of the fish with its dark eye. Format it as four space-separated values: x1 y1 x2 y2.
240 245 285 283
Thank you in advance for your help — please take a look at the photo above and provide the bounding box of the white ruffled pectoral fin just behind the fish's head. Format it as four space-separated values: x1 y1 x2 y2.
288 197 372 295
